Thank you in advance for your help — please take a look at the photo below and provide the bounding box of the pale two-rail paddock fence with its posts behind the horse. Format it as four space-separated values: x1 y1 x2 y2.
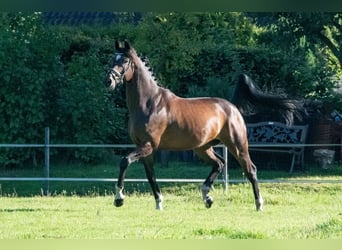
0 128 342 194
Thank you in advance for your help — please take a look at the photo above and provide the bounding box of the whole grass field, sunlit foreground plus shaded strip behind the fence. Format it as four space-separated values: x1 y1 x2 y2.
0 160 342 239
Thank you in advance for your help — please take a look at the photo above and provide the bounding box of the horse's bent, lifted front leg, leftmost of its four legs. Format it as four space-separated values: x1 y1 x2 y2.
114 144 152 207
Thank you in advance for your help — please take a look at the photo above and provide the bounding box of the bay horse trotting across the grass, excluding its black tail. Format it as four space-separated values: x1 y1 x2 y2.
109 41 263 211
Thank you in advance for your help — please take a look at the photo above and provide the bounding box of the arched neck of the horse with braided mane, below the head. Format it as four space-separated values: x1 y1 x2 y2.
126 62 159 113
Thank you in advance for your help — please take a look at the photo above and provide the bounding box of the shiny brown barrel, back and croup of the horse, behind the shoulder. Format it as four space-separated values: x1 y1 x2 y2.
156 93 244 150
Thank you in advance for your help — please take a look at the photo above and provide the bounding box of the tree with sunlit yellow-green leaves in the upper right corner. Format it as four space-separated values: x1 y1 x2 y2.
255 12 342 108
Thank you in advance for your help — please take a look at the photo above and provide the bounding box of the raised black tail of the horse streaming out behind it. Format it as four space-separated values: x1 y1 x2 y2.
232 74 318 125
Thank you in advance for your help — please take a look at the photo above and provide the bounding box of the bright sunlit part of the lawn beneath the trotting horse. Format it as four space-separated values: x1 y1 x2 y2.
0 184 342 239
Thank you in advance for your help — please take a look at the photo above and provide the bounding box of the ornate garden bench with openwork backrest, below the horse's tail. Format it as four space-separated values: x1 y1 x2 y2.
247 122 308 174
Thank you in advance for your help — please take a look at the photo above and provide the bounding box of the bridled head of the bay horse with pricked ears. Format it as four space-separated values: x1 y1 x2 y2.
109 40 134 89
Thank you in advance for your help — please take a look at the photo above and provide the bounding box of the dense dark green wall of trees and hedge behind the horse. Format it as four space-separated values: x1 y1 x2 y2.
0 13 342 165
